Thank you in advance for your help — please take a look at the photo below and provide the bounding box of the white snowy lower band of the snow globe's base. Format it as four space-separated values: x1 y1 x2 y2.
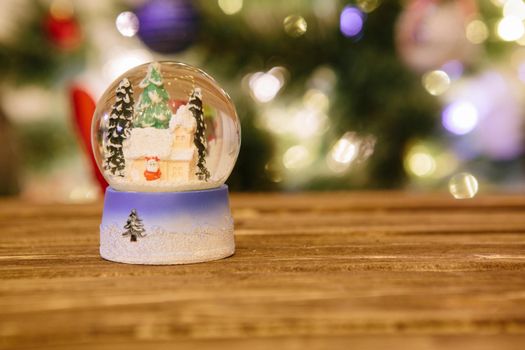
100 226 235 265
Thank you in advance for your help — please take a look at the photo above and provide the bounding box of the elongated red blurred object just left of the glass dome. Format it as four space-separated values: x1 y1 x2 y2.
69 85 108 193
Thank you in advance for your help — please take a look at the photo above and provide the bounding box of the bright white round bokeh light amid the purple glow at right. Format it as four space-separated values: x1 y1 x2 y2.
442 101 479 135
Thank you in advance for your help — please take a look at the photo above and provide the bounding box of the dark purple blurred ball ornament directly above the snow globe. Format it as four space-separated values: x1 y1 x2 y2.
136 0 199 54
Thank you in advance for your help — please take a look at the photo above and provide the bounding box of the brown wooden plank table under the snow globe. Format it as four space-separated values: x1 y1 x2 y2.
0 192 525 350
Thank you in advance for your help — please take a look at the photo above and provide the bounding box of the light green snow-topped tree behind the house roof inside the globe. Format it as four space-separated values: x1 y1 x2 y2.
133 62 171 129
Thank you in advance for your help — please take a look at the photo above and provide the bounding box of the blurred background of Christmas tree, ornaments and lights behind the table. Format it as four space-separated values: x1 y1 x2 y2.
0 0 525 202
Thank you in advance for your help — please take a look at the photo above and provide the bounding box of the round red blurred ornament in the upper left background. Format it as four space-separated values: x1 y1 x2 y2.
44 14 82 51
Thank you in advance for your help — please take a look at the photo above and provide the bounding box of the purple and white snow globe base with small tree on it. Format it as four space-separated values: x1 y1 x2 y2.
100 185 235 265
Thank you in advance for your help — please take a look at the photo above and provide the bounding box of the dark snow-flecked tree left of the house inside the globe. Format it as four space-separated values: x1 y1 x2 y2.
104 78 134 176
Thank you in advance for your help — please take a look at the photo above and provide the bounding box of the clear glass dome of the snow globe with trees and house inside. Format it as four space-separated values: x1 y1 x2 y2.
92 62 241 192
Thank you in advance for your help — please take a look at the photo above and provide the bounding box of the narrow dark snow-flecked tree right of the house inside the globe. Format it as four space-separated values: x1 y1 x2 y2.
188 88 210 181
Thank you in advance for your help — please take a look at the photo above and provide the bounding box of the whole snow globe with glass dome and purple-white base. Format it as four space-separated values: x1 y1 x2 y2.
92 62 241 265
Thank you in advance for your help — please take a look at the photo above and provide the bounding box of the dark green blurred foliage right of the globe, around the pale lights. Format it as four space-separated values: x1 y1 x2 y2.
194 1 439 190
